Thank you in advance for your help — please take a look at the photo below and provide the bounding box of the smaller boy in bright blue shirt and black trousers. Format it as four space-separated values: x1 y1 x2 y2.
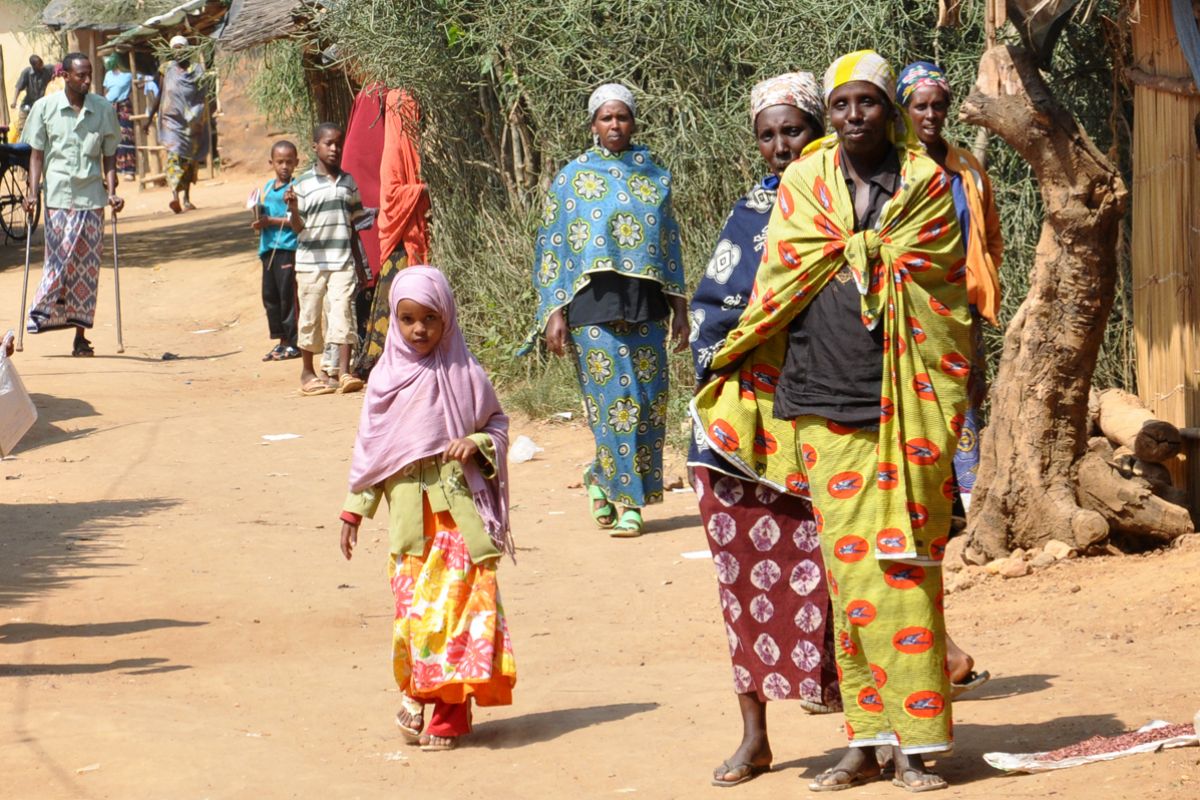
250 139 300 361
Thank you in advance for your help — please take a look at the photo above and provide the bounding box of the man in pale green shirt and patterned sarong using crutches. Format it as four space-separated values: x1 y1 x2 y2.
22 53 125 356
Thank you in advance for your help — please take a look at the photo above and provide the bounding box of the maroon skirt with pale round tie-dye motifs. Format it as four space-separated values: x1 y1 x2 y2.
696 467 841 714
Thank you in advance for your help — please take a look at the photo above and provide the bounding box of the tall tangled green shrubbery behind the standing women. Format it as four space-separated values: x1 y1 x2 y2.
317 0 1132 428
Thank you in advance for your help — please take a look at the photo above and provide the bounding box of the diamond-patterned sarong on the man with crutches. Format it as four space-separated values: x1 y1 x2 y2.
25 209 104 333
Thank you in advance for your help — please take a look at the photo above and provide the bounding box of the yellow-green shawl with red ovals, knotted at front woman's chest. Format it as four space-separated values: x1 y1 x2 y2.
692 137 970 559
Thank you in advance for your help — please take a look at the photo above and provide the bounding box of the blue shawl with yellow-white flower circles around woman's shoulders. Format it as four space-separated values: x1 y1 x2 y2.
518 145 685 355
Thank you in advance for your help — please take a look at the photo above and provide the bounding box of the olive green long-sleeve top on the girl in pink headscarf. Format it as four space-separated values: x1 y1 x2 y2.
342 433 500 564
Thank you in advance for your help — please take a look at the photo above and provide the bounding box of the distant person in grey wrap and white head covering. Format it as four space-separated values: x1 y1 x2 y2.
146 36 211 213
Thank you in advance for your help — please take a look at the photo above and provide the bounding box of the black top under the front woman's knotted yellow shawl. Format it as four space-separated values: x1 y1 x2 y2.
774 149 900 427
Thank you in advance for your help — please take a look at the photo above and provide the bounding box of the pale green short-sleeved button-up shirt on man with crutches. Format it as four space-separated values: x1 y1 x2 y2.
20 91 121 209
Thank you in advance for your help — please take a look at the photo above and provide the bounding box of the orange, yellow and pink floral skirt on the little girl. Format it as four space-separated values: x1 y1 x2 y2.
388 504 517 705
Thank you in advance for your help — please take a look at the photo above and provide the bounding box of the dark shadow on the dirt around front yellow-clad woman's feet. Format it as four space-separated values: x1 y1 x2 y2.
775 714 1126 787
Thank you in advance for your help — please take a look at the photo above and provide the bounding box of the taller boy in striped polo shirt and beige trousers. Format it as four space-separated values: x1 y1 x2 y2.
283 122 365 396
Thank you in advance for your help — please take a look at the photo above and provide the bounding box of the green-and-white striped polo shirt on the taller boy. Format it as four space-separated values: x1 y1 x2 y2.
292 167 366 272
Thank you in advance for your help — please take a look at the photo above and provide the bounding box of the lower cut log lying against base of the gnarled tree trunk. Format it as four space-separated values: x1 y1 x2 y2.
1076 451 1195 545
